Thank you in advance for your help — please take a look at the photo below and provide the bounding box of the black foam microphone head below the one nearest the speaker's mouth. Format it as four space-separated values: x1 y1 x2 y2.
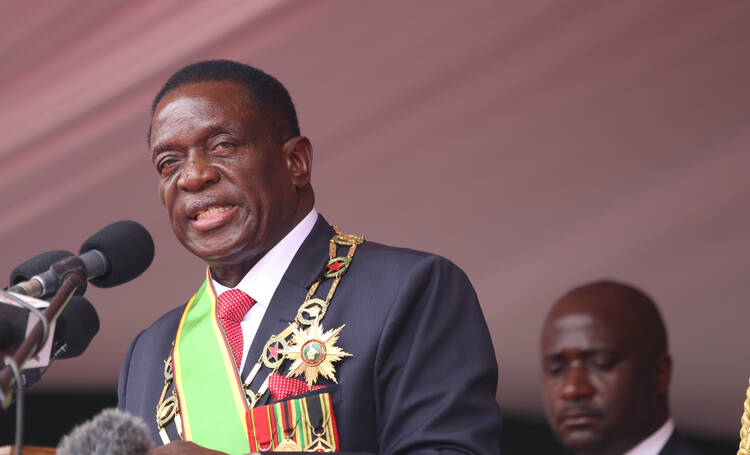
52 295 99 359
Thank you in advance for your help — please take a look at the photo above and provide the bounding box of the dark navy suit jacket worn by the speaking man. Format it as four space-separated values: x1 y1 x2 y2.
118 217 500 454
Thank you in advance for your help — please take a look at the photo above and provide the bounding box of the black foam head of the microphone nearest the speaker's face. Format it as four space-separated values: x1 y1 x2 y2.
80 220 154 288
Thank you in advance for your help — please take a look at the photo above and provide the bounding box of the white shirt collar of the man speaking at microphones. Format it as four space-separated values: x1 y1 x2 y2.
211 208 318 308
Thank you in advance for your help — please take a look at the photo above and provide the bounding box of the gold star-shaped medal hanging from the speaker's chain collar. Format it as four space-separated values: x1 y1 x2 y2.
281 322 351 386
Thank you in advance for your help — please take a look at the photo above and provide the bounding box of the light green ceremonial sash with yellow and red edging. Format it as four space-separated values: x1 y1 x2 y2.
172 268 250 454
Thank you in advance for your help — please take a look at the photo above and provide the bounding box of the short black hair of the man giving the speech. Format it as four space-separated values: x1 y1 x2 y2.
148 60 300 144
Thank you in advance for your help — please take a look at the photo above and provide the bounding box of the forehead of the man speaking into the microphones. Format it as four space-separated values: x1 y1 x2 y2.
151 81 259 142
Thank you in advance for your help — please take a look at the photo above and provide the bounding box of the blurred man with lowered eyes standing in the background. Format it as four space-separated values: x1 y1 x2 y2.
541 281 697 455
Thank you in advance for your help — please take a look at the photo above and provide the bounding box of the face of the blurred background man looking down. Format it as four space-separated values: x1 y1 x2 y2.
542 305 655 453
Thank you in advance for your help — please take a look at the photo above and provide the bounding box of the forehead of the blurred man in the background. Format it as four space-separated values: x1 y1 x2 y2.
542 312 630 354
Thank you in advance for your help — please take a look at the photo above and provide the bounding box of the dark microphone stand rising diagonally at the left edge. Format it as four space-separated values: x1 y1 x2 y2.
0 257 87 455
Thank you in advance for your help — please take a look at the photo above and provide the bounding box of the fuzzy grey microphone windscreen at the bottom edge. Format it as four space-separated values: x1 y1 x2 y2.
57 408 154 455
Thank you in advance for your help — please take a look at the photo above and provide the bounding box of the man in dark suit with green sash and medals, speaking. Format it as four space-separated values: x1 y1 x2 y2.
118 61 500 454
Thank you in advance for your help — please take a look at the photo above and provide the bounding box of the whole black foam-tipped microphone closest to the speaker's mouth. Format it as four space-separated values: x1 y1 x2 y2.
8 220 154 297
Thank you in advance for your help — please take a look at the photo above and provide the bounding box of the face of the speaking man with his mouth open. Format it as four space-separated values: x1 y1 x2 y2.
151 81 298 266
